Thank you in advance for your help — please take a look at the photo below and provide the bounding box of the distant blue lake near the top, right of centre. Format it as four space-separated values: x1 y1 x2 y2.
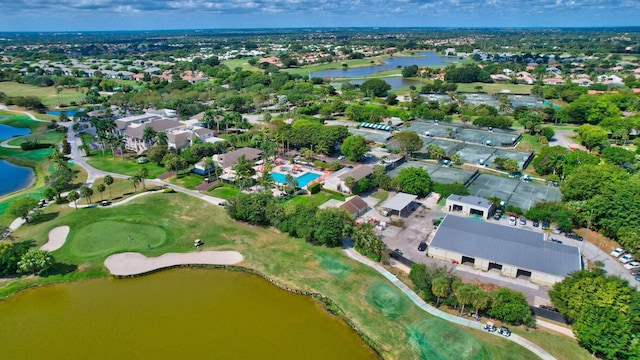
310 51 460 78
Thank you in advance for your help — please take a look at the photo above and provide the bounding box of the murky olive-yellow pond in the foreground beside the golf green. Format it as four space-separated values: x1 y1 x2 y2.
0 269 376 360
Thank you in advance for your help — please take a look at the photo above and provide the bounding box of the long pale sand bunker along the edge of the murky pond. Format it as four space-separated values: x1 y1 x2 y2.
104 251 244 276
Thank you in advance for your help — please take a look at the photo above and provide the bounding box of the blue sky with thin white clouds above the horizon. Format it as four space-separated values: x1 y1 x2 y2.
0 0 640 31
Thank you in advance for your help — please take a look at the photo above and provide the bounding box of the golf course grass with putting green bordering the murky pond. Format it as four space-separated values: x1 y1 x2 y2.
5 193 536 360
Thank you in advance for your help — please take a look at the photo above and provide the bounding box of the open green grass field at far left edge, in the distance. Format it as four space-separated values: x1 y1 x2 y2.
0 81 84 107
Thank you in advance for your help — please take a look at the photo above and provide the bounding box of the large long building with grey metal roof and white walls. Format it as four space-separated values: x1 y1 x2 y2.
429 215 582 286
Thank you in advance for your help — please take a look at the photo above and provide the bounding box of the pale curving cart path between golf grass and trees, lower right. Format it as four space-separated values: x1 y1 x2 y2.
343 244 555 360
